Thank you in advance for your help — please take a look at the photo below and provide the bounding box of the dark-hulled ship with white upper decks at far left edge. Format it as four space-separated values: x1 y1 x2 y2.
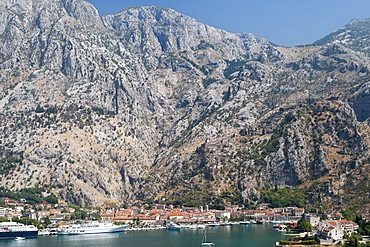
0 222 39 239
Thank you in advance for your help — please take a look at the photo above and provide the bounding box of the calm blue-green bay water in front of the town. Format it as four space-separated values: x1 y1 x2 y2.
0 223 288 247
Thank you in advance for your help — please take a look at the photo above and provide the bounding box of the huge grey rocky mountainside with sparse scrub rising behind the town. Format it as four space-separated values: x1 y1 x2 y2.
0 0 370 213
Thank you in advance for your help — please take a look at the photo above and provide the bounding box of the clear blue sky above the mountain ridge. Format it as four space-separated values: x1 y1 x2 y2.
87 0 370 46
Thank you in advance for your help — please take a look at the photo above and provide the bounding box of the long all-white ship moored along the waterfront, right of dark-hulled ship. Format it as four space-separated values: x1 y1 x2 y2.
57 222 128 235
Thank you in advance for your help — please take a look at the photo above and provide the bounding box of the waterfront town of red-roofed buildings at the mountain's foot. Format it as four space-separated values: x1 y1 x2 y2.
0 197 369 246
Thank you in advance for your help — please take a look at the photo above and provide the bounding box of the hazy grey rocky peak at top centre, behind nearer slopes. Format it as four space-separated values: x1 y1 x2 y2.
102 6 274 59
